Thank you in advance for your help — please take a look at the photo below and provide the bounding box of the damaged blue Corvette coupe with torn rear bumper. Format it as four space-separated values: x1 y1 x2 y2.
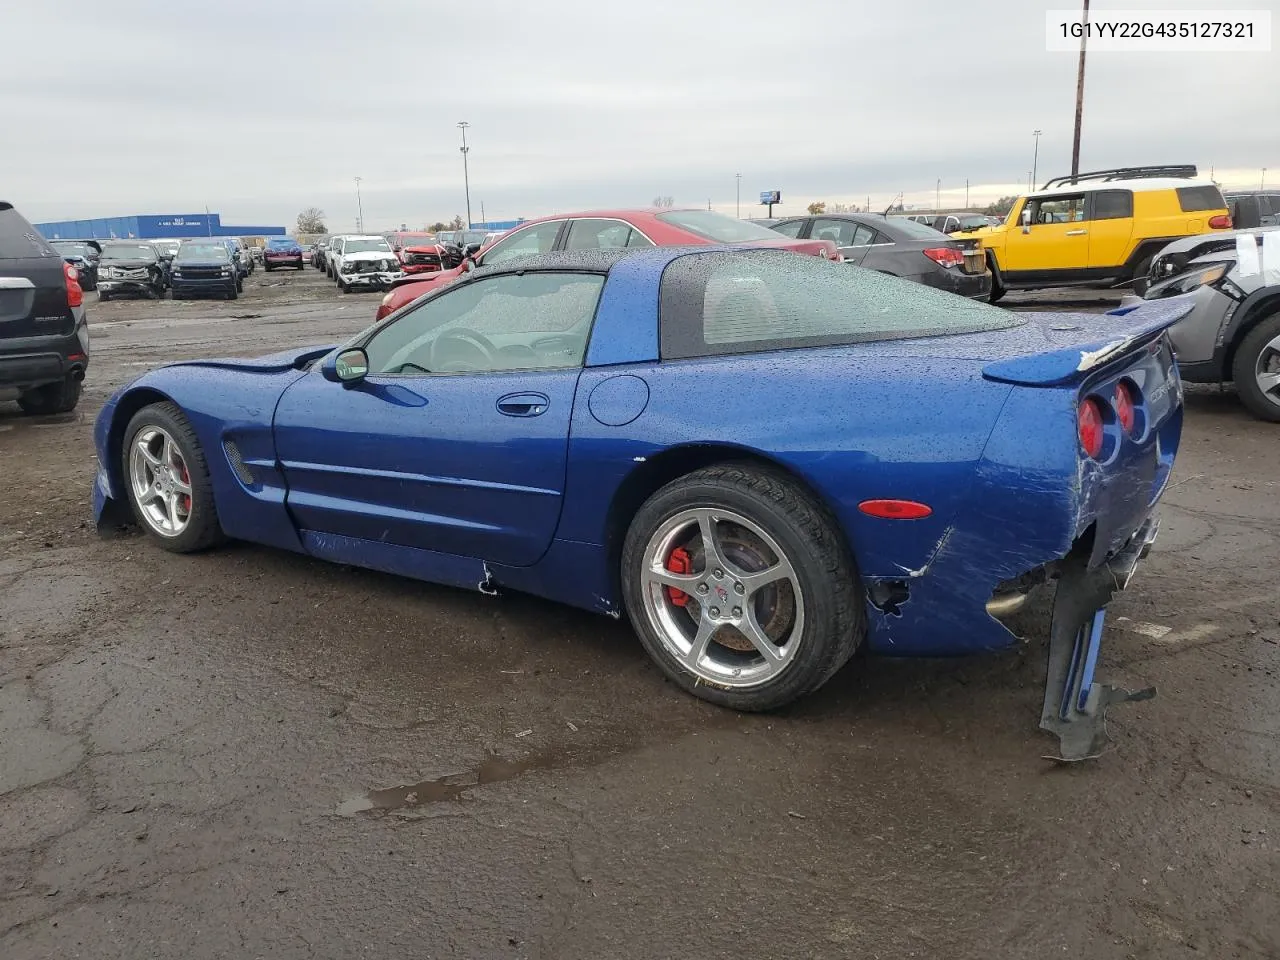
93 247 1188 759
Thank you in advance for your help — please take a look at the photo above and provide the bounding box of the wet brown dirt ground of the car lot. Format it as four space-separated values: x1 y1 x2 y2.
0 269 1280 960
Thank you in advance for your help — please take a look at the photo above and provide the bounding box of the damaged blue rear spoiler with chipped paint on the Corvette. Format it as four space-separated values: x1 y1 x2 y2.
982 294 1194 387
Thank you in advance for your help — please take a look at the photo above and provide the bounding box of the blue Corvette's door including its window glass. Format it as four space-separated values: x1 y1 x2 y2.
275 271 604 566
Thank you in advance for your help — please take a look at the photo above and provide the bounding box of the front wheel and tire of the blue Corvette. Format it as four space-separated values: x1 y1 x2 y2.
120 401 225 553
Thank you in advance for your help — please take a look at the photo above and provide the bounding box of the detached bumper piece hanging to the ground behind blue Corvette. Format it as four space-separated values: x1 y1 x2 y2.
1041 518 1158 762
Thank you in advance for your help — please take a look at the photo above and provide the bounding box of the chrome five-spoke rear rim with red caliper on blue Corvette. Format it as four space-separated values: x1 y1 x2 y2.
643 507 805 687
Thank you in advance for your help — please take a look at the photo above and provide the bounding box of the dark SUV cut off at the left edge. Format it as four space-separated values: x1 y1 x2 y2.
0 201 88 413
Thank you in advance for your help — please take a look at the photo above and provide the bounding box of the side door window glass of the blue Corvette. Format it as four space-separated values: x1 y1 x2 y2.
365 273 604 376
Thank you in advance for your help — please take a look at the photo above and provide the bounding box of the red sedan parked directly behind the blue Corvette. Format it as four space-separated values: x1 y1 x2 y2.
375 210 841 320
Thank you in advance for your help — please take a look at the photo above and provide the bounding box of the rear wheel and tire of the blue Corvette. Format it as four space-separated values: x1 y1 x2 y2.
621 463 867 710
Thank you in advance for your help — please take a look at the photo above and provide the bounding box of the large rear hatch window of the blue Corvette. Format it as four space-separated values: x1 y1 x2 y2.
659 251 1024 360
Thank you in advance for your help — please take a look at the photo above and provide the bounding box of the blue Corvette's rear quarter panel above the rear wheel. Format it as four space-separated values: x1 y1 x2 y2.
557 347 1011 619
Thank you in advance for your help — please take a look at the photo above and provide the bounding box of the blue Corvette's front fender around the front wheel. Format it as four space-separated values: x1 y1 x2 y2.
99 361 311 550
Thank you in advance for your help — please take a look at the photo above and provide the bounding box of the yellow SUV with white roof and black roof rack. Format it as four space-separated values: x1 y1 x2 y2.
964 166 1231 303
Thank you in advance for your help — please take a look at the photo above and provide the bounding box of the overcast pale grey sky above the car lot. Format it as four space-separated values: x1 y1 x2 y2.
0 0 1280 229
